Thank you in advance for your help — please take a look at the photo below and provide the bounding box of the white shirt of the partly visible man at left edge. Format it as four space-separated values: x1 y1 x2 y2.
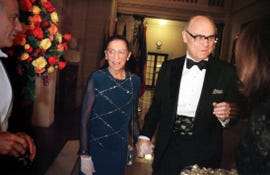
0 50 12 131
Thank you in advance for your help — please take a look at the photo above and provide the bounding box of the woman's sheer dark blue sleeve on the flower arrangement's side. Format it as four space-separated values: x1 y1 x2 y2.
79 76 95 155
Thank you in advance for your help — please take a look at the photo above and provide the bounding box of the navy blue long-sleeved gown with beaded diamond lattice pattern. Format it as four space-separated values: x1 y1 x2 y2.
79 68 140 175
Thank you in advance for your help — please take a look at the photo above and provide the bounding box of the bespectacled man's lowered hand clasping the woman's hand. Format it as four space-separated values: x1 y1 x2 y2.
136 139 154 158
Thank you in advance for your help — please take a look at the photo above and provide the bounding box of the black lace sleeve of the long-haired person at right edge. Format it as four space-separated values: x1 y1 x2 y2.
236 112 270 174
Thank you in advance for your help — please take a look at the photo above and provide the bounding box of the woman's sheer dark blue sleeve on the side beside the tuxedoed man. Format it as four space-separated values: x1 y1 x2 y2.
129 76 140 146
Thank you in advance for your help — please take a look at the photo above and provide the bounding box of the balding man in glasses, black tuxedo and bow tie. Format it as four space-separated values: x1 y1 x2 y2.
136 16 238 175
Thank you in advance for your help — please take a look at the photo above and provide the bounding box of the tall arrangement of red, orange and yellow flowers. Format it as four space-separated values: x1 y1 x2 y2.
7 0 71 100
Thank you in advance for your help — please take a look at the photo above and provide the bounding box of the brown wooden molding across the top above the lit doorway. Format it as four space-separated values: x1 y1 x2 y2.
117 0 231 22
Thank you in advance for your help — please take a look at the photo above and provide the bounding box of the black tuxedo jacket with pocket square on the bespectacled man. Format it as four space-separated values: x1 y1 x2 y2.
141 57 238 168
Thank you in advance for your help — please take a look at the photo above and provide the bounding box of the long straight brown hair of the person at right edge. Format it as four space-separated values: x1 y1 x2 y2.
235 16 270 105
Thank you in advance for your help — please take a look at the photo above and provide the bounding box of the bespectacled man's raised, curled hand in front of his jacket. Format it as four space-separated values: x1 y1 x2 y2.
213 102 238 121
